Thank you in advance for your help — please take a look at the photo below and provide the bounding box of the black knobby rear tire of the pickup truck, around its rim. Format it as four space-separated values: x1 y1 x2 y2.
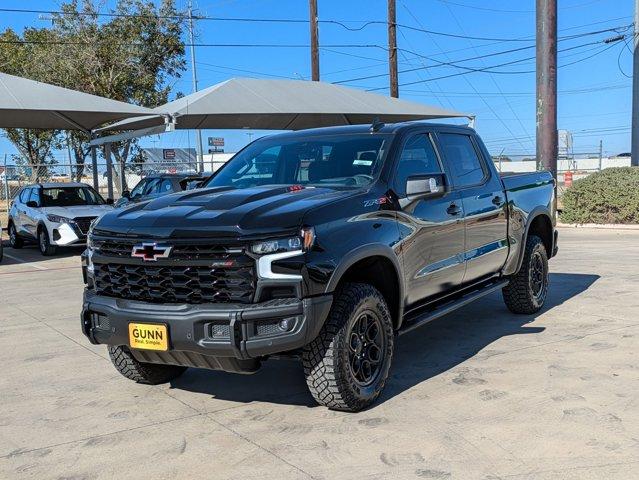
502 235 548 315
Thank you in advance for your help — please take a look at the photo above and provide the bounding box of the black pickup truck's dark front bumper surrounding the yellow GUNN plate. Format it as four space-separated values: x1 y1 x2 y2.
82 289 333 372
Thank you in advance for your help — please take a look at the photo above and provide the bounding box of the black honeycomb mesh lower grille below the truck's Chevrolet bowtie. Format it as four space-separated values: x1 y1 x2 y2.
94 255 255 304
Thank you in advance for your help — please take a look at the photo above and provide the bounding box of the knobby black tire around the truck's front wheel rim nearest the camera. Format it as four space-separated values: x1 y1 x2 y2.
302 283 394 412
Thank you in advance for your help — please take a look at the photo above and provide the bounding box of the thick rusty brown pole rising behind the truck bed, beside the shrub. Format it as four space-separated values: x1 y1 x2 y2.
537 0 558 180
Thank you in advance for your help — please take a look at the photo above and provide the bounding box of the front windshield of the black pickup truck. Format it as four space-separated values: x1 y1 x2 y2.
204 133 392 188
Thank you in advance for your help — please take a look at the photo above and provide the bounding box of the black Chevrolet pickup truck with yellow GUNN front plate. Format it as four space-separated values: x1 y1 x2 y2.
81 122 557 411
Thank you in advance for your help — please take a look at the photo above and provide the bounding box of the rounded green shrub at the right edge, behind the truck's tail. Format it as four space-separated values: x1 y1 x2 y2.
560 167 639 223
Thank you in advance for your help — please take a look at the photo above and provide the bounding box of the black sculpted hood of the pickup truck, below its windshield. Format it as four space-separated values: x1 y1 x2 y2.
95 185 360 238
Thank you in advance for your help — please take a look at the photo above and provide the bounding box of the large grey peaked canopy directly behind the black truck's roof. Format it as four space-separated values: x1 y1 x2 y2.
100 78 472 131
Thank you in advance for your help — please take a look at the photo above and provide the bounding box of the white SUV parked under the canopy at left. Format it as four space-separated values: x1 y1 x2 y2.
7 183 113 255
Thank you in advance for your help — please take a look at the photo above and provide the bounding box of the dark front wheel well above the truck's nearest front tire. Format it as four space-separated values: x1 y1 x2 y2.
336 255 400 328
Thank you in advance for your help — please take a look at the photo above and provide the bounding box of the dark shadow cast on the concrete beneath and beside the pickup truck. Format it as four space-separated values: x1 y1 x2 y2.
172 273 600 408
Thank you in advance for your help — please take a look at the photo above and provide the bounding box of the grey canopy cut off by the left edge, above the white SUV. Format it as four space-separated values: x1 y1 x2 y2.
0 72 155 132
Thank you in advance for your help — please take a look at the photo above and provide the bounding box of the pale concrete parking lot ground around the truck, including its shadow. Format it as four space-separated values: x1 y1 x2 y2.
0 229 639 480
